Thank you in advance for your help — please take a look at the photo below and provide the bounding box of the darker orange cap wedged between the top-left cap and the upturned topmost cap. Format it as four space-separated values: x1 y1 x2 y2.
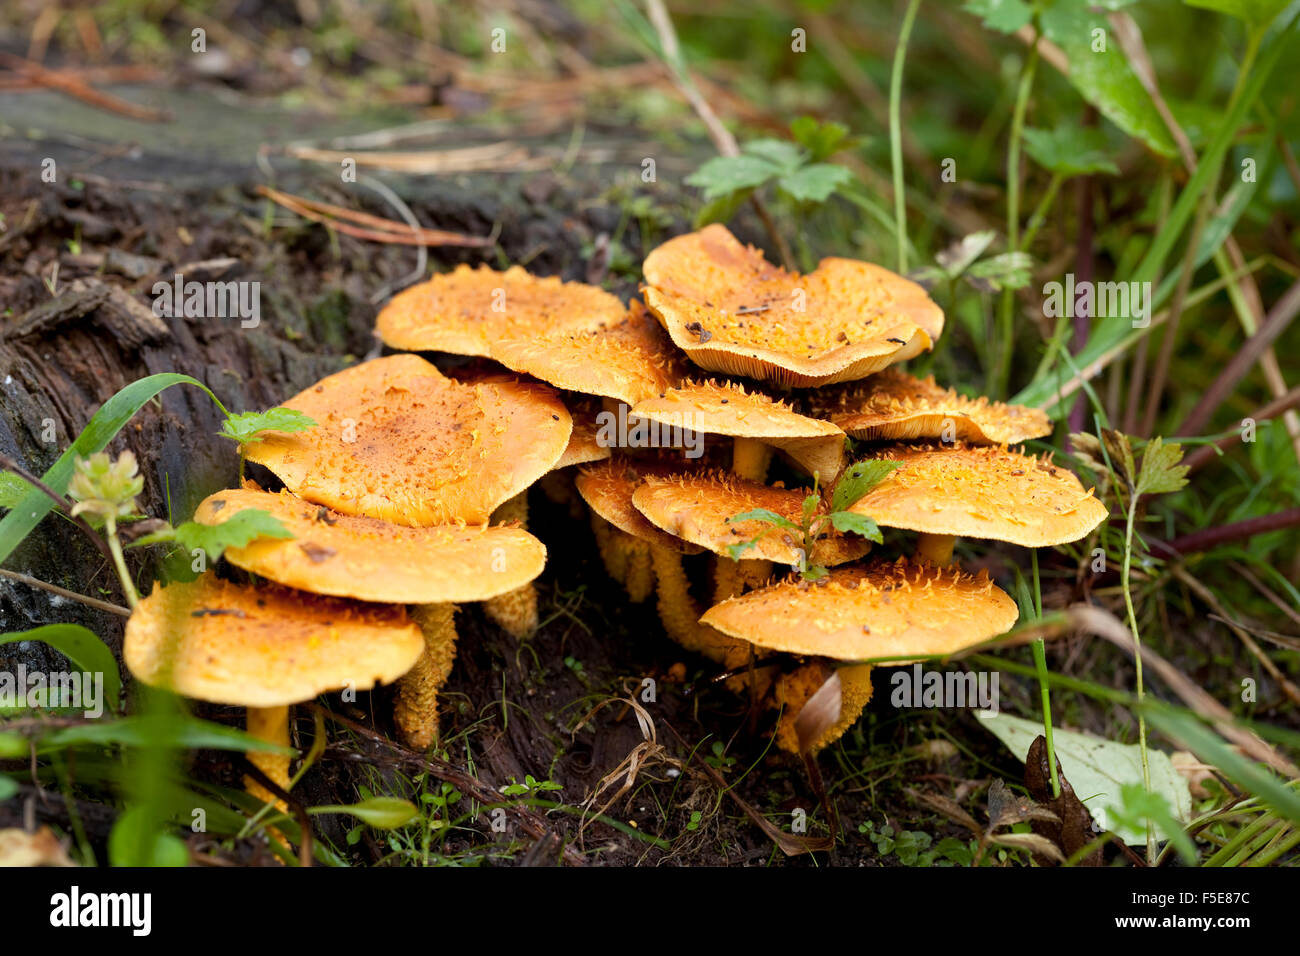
491 300 685 405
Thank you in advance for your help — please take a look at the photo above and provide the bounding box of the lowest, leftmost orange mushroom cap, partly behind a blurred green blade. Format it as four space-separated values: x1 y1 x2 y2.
122 574 424 708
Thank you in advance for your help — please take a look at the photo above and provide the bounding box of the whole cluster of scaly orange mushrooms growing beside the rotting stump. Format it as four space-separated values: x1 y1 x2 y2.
126 225 1106 822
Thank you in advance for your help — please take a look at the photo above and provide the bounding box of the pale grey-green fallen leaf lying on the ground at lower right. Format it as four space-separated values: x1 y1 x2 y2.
979 713 1192 844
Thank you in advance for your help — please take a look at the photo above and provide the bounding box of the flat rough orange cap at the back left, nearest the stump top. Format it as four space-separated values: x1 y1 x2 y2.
374 265 625 358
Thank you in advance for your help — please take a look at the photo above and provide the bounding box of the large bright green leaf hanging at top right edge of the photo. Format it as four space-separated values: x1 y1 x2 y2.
1040 0 1178 156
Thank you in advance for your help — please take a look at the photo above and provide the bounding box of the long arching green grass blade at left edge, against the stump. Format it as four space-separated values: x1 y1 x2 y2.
0 372 226 563
